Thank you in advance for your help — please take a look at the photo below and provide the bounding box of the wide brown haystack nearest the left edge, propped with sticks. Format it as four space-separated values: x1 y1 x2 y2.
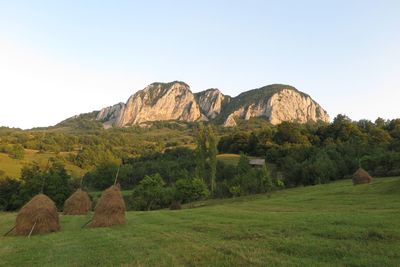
15 194 60 235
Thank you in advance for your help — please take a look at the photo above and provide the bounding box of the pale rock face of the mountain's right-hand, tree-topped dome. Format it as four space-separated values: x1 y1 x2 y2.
220 88 329 127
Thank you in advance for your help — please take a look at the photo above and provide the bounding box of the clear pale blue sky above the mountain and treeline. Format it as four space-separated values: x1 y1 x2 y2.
0 0 400 128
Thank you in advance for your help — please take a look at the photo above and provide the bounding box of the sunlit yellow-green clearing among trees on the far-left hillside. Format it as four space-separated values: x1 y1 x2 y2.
0 149 86 178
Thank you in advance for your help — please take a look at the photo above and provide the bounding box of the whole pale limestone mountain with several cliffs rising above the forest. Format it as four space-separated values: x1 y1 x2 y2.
96 81 329 128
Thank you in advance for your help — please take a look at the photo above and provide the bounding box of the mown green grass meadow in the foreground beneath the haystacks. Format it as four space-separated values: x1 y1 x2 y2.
0 178 400 267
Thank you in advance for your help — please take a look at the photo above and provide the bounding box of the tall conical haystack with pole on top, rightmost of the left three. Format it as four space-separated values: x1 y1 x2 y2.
91 185 125 227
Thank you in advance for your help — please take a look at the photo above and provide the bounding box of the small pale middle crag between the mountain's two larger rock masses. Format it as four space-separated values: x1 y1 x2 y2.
195 89 230 119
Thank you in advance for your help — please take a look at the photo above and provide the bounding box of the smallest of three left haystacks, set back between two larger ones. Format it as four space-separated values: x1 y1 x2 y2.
64 189 92 215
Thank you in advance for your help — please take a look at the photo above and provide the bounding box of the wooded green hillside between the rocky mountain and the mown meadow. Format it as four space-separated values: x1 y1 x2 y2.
0 115 400 213
